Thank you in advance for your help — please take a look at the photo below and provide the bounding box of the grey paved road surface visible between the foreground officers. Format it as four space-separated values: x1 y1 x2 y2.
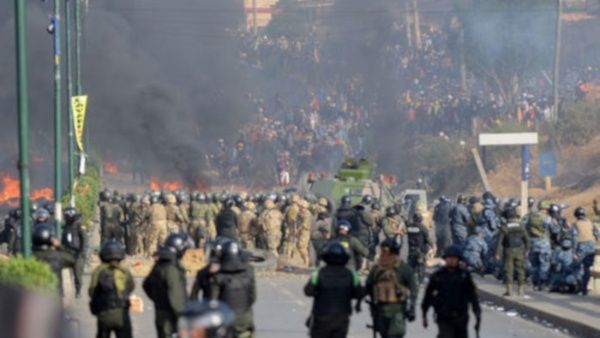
73 273 568 338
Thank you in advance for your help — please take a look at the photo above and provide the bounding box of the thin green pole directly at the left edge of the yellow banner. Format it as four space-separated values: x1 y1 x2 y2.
65 0 75 207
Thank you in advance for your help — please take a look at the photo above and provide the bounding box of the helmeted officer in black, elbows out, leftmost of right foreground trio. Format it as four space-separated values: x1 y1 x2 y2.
304 242 363 338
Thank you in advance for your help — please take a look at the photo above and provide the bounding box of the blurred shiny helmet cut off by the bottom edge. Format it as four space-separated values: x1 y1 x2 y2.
179 300 235 338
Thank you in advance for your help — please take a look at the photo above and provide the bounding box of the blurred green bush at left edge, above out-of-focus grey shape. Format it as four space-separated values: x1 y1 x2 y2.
0 257 58 293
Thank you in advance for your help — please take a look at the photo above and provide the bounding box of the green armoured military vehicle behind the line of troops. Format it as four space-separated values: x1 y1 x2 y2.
301 159 396 208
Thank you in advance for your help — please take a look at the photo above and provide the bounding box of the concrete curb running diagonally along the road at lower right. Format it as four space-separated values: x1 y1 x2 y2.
477 288 600 337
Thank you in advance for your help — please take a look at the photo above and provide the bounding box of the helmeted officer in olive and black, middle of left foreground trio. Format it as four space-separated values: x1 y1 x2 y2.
143 234 187 338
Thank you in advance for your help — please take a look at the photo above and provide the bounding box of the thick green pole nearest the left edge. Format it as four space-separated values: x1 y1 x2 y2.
15 0 31 258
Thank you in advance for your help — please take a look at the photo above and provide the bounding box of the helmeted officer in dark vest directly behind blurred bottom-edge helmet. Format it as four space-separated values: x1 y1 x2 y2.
209 241 256 338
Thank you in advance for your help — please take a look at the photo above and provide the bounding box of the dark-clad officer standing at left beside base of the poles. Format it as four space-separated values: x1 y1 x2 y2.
62 207 88 298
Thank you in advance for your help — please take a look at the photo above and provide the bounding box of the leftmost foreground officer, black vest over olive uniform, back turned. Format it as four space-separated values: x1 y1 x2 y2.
88 240 135 338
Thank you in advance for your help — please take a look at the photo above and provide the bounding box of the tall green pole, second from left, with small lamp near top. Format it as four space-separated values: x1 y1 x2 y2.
52 0 62 238
